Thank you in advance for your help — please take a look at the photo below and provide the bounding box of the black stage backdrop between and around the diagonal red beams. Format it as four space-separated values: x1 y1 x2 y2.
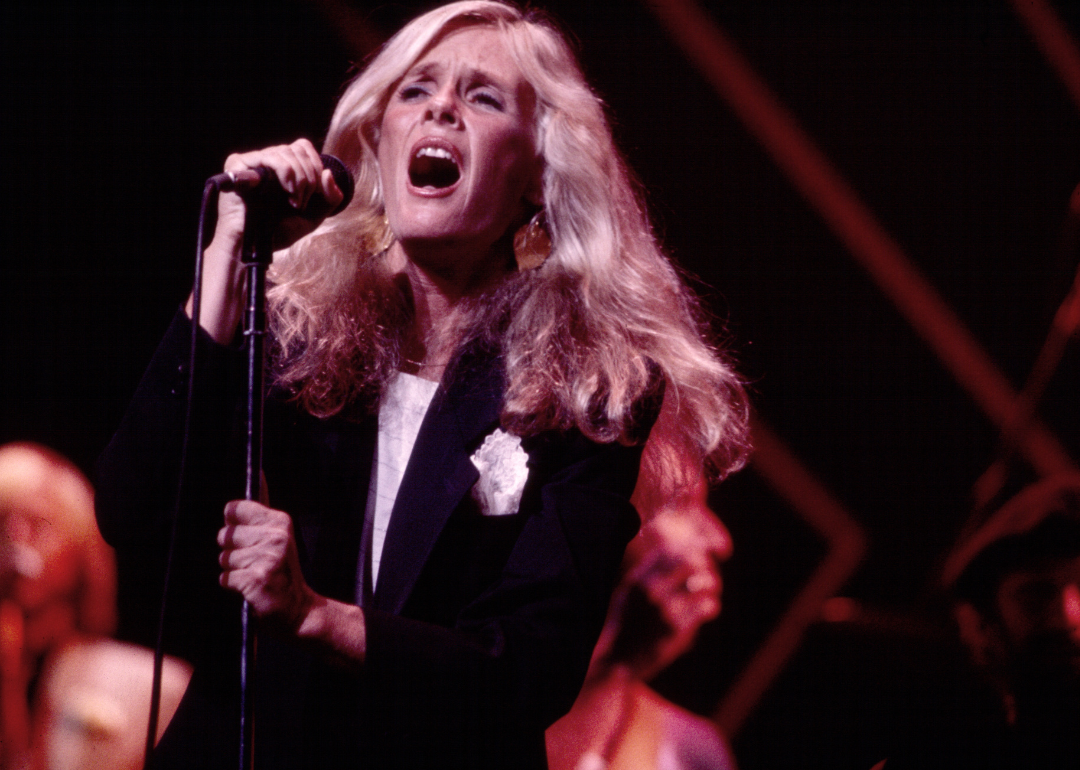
0 0 1080 770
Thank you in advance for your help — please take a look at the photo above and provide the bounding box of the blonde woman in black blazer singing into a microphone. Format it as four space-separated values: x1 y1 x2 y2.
98 0 747 770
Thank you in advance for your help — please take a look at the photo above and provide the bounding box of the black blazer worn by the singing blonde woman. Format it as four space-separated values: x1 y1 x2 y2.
98 313 659 770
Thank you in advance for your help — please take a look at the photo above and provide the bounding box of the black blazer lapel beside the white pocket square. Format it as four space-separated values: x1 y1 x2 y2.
375 357 503 613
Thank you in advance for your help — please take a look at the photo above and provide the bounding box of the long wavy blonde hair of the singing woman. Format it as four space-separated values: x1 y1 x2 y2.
270 0 748 476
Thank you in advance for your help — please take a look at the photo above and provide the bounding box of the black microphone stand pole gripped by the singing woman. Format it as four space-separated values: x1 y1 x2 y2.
240 201 273 770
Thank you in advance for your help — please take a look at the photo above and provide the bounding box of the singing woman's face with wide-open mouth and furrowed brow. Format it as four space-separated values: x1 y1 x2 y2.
378 26 540 276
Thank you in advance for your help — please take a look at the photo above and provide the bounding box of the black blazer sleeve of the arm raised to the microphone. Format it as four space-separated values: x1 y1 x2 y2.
95 311 244 662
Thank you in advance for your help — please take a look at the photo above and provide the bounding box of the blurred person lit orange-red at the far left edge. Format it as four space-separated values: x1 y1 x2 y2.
0 443 190 770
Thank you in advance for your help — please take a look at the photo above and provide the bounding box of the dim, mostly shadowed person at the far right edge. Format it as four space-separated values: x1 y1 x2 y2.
878 473 1080 770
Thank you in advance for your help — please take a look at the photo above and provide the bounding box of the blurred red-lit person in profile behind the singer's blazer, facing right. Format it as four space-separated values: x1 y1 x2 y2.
546 412 735 770
